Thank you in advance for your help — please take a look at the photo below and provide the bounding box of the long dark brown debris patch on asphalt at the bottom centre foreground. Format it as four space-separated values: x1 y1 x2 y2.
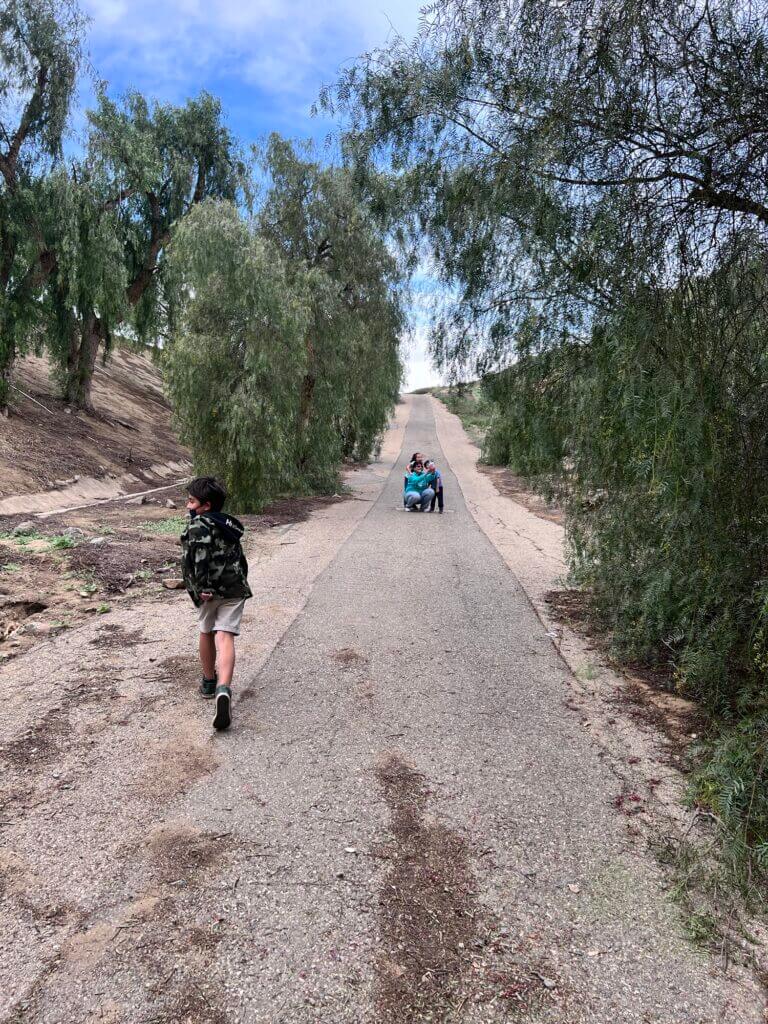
377 757 544 1024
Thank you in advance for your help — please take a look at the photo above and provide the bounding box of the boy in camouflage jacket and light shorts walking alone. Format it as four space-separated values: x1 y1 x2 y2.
181 476 253 730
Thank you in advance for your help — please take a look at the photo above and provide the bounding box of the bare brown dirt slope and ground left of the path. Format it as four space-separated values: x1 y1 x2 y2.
0 350 348 662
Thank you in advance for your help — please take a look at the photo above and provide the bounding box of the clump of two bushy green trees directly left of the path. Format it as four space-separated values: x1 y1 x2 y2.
164 137 403 510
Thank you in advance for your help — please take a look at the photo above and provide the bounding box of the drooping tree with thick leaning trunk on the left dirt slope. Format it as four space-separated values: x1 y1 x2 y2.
52 92 247 409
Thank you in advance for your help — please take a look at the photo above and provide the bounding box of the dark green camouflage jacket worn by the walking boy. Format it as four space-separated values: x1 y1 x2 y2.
181 512 252 606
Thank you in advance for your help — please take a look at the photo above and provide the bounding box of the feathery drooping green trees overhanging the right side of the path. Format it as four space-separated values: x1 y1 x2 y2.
326 0 768 900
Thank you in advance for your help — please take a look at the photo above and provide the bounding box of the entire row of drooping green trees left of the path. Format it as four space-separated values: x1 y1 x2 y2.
0 0 404 511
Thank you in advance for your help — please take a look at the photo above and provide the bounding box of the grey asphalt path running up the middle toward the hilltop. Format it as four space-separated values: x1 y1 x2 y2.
17 398 762 1024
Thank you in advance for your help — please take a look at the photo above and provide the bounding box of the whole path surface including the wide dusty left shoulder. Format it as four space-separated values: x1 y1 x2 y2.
0 398 764 1024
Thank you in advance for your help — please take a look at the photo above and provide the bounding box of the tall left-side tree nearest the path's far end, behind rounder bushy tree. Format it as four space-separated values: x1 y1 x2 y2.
258 135 404 485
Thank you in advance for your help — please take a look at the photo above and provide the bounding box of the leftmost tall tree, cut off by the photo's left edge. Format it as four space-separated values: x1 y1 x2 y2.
0 0 84 411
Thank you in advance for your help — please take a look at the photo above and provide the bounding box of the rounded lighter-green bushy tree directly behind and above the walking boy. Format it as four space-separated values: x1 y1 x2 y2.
163 201 309 509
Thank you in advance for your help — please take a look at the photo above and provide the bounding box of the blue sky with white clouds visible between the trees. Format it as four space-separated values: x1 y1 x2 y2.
81 0 439 389
